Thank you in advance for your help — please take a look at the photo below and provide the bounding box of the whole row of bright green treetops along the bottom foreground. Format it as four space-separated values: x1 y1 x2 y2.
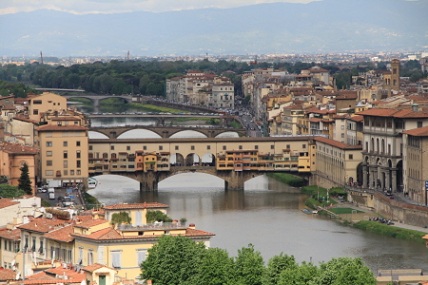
141 236 376 285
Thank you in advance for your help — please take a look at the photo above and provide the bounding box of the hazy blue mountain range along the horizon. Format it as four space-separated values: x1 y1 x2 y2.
0 0 428 56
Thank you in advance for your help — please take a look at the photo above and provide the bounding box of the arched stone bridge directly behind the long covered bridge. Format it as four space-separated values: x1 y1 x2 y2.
89 126 247 139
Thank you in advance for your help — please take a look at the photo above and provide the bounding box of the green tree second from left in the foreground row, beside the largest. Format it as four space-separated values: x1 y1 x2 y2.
191 248 235 285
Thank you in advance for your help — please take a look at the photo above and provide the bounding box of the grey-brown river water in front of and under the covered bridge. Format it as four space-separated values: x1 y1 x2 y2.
90 173 428 272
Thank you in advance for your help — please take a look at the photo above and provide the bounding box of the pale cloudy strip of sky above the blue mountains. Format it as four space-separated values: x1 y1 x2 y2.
0 0 316 15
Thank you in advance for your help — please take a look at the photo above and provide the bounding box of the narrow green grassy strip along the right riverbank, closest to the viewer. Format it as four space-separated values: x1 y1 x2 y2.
352 221 426 244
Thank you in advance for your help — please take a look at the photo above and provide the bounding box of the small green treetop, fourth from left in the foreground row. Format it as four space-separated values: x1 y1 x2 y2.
262 253 297 285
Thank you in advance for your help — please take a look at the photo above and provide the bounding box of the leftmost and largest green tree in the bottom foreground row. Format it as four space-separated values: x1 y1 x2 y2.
141 236 206 285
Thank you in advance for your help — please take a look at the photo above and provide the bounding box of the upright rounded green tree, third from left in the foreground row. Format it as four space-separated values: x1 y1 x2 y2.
235 244 265 285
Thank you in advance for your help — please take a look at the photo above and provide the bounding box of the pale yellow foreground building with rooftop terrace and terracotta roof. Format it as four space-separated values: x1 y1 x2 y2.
71 203 214 279
